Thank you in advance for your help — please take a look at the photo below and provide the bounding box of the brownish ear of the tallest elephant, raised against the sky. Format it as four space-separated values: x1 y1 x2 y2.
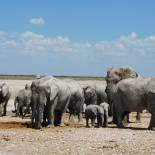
120 67 138 80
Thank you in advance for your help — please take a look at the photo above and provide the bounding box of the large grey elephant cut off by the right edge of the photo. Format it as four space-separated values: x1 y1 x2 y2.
113 77 155 130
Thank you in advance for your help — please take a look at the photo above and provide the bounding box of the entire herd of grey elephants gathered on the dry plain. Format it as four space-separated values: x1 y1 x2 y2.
0 67 155 130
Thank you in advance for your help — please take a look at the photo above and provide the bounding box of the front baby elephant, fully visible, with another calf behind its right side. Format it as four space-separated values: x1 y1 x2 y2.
85 104 104 127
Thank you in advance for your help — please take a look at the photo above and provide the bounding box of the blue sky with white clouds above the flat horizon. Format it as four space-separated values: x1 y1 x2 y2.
0 0 155 77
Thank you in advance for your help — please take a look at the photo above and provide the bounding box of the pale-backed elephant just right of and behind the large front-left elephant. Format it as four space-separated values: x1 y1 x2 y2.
65 80 85 122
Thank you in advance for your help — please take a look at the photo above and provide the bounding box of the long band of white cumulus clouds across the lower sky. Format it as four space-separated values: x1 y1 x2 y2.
0 32 155 57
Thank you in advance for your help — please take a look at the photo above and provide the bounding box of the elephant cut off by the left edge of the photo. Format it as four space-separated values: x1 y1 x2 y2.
0 82 11 116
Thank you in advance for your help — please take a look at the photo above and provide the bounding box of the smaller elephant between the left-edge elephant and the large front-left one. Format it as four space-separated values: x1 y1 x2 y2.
13 85 32 118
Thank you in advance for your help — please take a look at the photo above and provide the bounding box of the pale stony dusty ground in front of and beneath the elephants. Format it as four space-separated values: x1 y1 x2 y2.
0 80 155 155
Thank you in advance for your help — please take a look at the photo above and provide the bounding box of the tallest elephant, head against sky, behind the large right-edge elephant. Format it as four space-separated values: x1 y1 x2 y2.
106 67 142 122
